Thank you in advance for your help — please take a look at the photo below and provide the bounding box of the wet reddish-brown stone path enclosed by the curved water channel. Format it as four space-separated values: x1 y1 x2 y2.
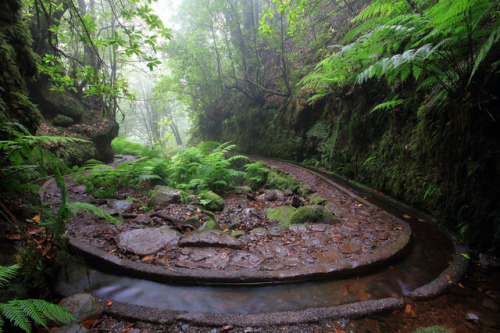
44 156 410 277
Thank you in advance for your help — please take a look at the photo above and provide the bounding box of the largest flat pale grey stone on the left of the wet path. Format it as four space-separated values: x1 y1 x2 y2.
115 227 180 256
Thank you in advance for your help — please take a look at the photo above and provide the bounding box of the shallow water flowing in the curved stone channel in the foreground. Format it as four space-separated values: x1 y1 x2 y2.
59 221 452 314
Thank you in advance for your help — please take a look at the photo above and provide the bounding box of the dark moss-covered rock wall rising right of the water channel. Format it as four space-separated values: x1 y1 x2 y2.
217 75 500 251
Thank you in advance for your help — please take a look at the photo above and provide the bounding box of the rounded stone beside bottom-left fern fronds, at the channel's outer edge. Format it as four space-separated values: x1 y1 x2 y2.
59 293 104 322
